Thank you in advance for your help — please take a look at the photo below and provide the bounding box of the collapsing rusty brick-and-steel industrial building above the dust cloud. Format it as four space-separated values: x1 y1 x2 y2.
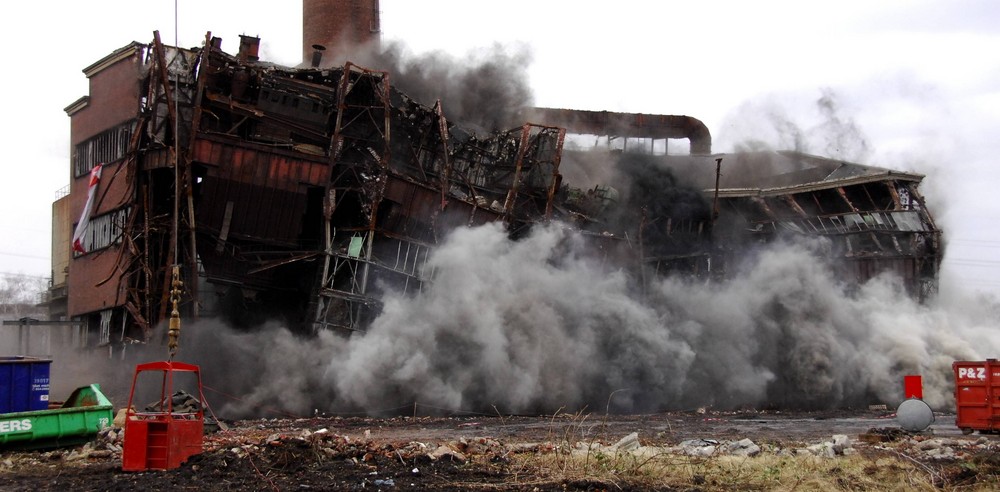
50 1 942 352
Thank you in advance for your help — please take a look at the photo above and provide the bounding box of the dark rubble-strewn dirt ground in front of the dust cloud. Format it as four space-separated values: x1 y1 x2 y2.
0 411 1000 491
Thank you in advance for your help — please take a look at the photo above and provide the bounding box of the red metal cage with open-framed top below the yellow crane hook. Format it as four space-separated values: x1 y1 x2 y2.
122 361 205 471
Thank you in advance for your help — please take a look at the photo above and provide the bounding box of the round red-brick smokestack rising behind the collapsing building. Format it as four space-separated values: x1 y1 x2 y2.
302 0 381 62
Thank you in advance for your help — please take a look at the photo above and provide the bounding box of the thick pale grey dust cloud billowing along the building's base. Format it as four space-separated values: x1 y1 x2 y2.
88 221 1000 417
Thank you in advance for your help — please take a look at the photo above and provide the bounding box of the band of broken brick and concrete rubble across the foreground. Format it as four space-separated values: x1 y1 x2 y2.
0 419 1000 469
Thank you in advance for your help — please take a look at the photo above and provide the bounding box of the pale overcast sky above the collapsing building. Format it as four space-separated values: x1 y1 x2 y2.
0 0 1000 292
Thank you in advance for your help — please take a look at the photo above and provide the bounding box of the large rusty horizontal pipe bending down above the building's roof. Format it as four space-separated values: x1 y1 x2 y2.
522 108 712 154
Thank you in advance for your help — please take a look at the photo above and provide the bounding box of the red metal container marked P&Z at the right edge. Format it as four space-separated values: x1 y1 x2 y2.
951 359 1000 434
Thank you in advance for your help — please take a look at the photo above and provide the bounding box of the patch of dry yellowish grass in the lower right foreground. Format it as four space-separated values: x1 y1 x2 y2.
498 414 1000 491
